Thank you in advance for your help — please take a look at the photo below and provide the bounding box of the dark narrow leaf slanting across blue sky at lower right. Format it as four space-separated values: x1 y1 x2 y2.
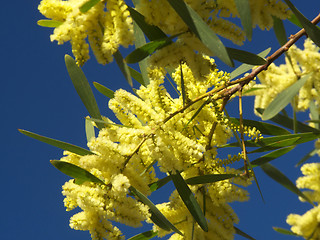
260 163 313 205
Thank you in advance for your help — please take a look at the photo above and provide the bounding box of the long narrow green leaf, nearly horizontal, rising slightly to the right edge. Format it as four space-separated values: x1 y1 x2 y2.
220 132 320 148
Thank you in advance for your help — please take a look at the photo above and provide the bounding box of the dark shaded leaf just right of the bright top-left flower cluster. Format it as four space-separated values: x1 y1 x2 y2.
128 4 167 41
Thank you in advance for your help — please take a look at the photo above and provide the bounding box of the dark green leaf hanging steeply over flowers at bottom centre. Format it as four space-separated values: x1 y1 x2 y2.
170 171 208 232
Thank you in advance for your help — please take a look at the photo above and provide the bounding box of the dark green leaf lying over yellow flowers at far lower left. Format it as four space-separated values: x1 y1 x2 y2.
50 160 105 184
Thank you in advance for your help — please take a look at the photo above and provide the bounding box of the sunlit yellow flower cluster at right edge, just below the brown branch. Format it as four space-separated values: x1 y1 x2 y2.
250 39 320 114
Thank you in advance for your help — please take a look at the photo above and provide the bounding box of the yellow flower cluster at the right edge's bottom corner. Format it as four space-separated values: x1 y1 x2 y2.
287 163 320 240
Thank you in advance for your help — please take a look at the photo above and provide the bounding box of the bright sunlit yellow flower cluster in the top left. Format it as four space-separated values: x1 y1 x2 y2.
38 0 133 65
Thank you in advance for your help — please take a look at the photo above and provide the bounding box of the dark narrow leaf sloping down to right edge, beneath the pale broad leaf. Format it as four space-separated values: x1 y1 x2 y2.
256 108 320 134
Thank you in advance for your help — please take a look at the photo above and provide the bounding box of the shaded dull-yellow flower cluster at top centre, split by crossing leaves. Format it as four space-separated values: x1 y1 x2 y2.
136 0 290 67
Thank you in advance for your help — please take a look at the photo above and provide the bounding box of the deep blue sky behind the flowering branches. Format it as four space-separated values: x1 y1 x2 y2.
0 0 320 240
